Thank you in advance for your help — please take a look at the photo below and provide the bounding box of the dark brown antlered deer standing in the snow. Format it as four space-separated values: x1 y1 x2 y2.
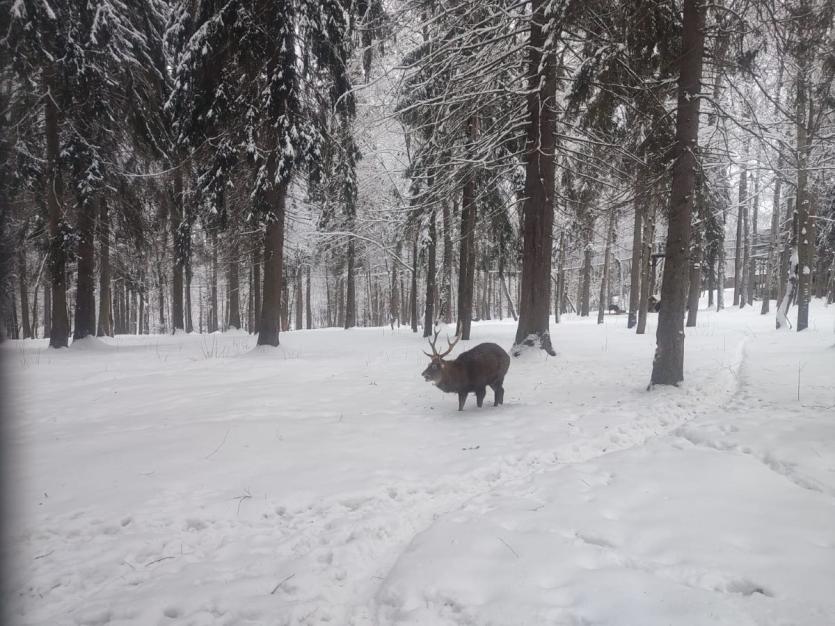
422 331 510 411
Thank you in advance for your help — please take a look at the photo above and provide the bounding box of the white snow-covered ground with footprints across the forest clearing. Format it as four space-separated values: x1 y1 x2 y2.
2 303 835 626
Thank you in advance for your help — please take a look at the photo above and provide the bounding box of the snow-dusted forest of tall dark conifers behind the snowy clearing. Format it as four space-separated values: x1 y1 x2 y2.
0 0 835 382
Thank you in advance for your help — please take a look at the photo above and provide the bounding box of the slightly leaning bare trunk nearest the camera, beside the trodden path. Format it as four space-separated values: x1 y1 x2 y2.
651 0 706 385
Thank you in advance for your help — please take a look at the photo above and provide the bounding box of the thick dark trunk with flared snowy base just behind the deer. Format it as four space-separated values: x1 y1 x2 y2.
514 0 557 356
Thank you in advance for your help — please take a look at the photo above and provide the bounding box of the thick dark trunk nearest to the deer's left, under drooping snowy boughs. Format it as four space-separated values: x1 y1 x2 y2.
258 182 287 346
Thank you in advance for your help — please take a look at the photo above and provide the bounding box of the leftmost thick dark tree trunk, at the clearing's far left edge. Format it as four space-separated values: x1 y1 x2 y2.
44 72 70 348
